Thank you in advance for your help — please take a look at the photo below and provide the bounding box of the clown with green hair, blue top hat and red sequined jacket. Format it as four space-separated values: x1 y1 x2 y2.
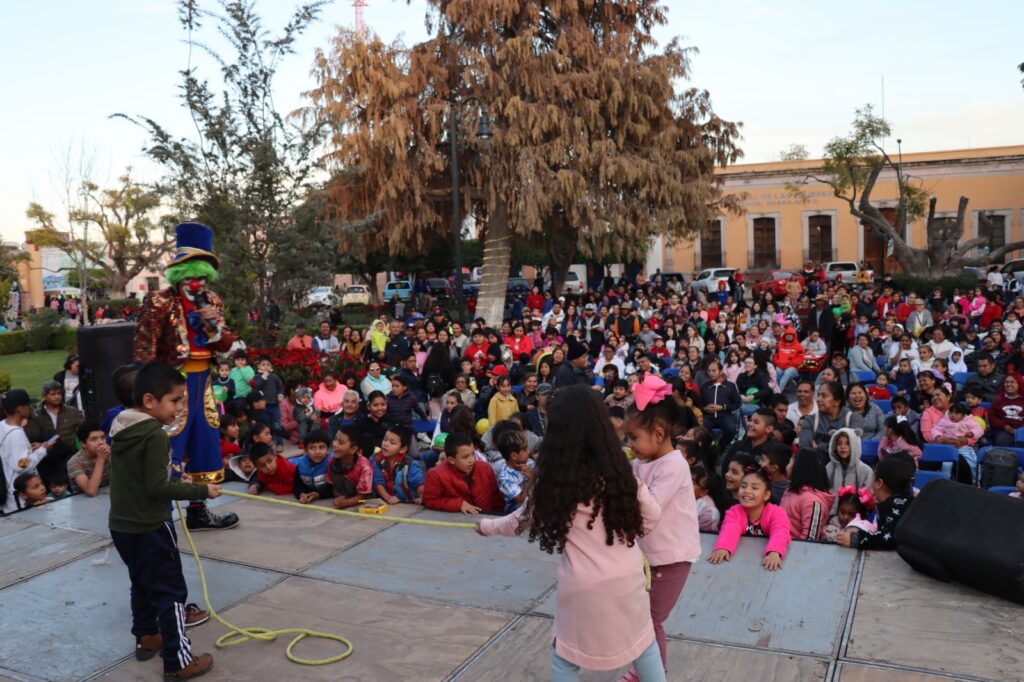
134 222 239 530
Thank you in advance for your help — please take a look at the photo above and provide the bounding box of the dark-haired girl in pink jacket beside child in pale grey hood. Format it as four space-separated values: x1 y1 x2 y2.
779 447 836 541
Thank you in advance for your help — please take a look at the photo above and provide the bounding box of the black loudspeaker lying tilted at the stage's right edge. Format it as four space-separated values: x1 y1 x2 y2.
896 479 1024 604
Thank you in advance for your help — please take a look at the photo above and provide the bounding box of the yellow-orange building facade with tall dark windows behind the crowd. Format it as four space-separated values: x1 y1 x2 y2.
648 145 1024 272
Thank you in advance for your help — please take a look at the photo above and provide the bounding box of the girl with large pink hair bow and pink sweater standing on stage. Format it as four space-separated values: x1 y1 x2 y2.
620 374 700 682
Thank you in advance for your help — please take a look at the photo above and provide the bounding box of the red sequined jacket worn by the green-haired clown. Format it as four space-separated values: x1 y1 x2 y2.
134 287 236 368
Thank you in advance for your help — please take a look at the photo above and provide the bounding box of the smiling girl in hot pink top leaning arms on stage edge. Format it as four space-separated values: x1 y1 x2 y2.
708 466 790 570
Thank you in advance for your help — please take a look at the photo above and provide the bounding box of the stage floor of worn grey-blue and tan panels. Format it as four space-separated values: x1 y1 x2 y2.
0 477 1024 682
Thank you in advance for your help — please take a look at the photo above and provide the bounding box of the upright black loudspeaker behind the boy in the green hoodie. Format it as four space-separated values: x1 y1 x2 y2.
78 323 135 421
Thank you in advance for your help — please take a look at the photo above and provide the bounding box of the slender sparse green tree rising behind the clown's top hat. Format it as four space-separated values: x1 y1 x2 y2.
119 0 329 340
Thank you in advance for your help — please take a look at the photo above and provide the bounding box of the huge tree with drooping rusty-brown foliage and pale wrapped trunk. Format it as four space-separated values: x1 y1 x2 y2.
309 0 739 324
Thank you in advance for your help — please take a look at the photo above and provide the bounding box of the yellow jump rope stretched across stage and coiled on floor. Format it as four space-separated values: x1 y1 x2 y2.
175 491 651 666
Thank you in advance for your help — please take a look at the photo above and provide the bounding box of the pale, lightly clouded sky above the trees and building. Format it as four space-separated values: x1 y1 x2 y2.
0 0 1024 242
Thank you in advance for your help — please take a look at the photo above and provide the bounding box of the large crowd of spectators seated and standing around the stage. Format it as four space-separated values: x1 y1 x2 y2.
0 264 1024 547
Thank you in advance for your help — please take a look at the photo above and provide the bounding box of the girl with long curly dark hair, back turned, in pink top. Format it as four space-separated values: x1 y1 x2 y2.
476 386 665 682
